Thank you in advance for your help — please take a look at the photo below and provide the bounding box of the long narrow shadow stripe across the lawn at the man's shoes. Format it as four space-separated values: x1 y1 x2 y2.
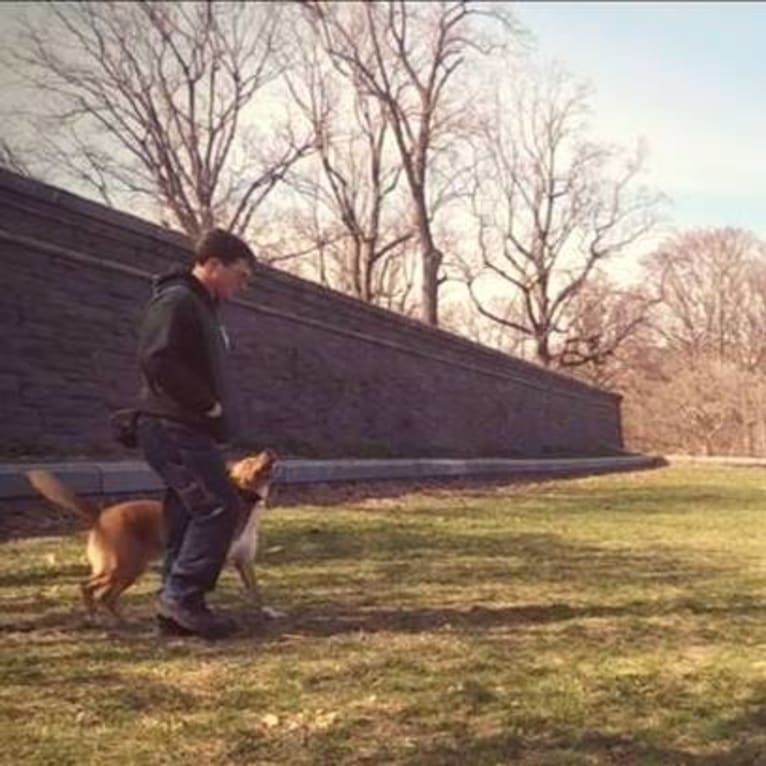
0 598 766 664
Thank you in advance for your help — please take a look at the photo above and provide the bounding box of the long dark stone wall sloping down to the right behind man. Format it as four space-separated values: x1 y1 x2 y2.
0 171 622 457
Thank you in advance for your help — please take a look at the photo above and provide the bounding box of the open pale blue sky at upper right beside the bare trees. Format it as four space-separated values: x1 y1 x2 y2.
512 2 766 238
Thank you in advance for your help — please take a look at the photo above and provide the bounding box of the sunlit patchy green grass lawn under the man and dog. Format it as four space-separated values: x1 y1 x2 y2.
0 466 766 766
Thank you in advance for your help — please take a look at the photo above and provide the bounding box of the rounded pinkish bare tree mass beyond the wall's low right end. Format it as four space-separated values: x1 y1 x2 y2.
621 228 766 455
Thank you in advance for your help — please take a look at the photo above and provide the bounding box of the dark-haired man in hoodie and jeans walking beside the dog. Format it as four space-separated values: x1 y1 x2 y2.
138 229 255 638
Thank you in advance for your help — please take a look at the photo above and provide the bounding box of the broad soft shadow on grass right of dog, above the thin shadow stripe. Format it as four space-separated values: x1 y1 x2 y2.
264 521 726 589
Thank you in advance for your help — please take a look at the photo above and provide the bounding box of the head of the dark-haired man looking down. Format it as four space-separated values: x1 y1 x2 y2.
192 229 255 300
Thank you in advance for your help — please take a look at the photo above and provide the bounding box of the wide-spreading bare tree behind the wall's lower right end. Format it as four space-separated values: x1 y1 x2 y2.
463 61 660 366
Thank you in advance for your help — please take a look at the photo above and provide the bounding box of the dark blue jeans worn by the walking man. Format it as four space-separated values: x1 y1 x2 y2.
138 415 242 608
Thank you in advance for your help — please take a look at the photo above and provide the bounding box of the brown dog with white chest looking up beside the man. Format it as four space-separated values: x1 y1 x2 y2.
27 450 278 619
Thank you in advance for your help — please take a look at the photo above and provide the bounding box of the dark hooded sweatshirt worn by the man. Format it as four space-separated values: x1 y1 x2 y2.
138 271 232 442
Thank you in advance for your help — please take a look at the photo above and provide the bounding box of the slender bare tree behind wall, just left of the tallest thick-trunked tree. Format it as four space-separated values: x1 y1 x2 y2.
284 31 413 304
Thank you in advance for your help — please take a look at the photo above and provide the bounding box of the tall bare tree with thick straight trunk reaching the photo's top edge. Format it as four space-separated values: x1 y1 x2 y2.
304 0 520 325
